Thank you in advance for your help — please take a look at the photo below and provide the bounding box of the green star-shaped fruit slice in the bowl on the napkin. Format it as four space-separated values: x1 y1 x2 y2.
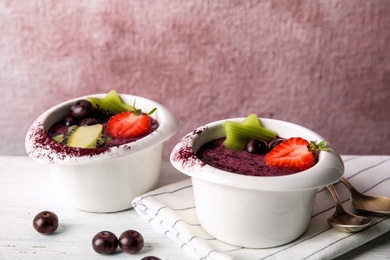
223 114 278 150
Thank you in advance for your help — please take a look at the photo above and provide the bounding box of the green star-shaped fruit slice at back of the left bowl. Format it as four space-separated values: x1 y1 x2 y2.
87 89 134 114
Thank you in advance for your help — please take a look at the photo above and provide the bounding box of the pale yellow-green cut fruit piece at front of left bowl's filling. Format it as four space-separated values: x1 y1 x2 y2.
66 124 103 148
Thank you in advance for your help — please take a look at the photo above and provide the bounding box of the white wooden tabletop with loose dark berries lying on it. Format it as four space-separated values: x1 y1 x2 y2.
0 156 390 260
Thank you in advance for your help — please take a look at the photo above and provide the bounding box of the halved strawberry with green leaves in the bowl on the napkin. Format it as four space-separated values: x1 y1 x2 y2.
264 137 330 171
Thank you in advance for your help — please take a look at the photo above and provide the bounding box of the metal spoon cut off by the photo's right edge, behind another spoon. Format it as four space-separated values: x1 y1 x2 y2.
340 177 390 215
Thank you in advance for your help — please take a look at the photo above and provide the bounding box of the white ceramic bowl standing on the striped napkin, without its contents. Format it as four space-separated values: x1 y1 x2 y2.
170 118 344 248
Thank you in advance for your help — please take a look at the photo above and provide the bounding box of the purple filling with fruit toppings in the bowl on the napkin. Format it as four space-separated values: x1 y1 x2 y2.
196 114 330 176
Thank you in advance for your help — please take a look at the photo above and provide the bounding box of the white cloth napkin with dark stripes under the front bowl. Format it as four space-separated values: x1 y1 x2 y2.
133 156 390 259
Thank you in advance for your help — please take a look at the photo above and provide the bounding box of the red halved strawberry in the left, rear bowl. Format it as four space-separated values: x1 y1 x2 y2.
106 111 151 139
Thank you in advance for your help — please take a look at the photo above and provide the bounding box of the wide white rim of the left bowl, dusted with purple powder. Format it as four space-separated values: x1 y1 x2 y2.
25 93 179 165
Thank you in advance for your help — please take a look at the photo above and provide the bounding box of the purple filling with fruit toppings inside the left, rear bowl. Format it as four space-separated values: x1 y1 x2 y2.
47 90 159 148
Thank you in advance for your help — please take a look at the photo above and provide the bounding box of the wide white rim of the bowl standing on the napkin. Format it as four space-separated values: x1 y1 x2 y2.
170 118 344 192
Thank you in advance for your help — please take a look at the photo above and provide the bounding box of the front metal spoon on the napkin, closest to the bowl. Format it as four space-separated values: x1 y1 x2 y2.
326 185 371 232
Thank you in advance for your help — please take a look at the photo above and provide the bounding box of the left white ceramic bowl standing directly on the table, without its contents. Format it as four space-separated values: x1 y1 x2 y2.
25 94 179 212
